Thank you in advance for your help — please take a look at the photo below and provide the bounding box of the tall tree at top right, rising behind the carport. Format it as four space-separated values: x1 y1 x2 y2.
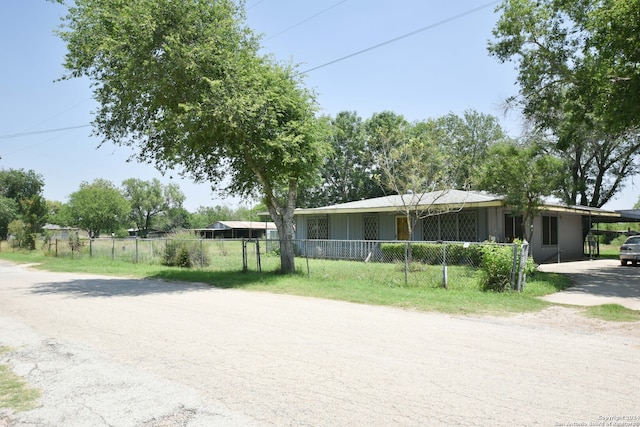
489 0 640 207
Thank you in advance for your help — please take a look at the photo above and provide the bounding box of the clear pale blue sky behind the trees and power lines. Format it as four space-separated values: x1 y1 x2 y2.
0 0 638 211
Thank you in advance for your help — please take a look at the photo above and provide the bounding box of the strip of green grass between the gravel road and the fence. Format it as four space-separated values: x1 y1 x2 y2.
0 246 571 315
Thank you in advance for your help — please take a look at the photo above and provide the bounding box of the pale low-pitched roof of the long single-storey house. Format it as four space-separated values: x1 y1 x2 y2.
294 190 624 221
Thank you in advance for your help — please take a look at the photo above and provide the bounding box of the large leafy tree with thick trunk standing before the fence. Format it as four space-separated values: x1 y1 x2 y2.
59 0 324 272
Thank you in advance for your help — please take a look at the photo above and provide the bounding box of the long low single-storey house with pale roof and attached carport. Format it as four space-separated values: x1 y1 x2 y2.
294 190 637 263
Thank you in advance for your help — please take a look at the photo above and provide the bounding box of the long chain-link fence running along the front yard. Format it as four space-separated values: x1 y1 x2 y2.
37 238 521 288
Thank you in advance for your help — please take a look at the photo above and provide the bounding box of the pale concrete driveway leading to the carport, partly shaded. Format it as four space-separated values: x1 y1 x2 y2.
540 259 640 310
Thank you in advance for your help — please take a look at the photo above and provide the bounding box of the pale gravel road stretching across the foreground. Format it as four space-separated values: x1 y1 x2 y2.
0 261 640 426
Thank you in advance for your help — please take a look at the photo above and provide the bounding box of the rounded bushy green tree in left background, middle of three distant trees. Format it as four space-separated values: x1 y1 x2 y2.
68 179 131 237
